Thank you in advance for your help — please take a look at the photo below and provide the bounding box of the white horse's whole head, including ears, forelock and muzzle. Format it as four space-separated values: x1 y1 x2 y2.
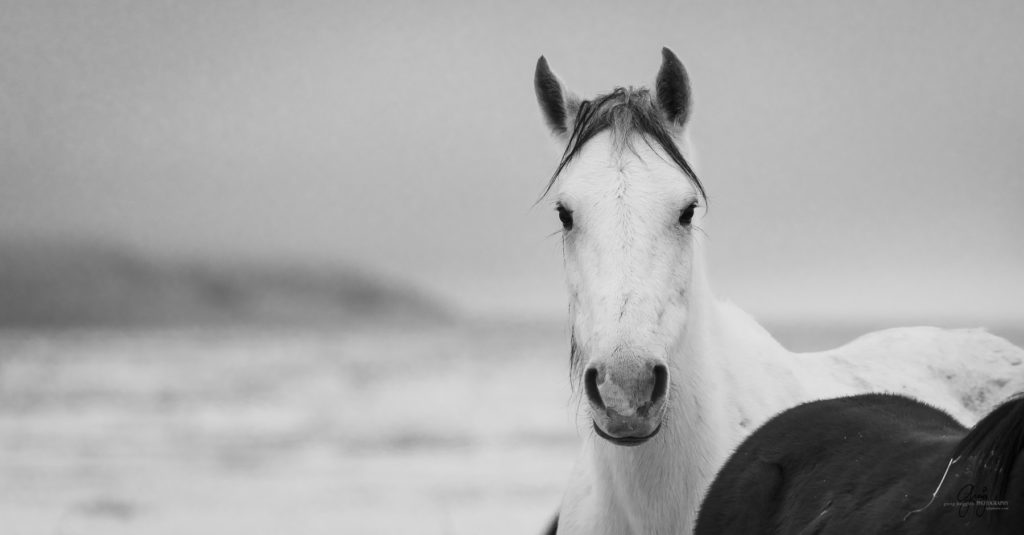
534 48 703 446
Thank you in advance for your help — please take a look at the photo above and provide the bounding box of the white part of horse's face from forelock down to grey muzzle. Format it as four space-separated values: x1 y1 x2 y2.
555 132 702 363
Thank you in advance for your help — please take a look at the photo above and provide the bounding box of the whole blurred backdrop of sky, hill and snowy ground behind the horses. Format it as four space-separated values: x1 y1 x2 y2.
0 0 1024 534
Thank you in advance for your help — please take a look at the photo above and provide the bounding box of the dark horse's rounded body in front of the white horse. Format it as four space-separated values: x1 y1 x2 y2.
695 394 1024 535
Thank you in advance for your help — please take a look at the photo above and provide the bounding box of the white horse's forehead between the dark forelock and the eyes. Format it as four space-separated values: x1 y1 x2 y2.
559 133 694 207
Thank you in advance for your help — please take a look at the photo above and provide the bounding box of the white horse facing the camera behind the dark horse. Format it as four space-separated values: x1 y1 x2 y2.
535 48 1024 535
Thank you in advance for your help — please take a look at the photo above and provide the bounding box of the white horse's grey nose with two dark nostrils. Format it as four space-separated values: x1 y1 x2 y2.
584 360 669 418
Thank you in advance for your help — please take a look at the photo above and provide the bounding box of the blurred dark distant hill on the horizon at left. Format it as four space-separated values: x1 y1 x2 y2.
0 242 450 327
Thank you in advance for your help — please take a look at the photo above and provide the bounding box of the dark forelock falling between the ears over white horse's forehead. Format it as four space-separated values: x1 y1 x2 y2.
542 87 708 202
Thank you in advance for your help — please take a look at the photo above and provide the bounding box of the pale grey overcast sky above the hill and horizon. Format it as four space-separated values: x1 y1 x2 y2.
0 0 1024 323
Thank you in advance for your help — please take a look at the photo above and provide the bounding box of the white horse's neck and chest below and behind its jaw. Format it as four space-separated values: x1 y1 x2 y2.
591 240 797 533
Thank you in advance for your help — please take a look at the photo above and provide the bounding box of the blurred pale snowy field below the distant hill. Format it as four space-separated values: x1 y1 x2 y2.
0 317 1024 535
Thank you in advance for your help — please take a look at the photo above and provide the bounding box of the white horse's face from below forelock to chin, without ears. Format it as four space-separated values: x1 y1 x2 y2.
553 134 701 445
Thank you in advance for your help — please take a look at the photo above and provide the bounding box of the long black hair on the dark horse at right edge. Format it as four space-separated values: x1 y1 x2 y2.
953 393 1024 499
